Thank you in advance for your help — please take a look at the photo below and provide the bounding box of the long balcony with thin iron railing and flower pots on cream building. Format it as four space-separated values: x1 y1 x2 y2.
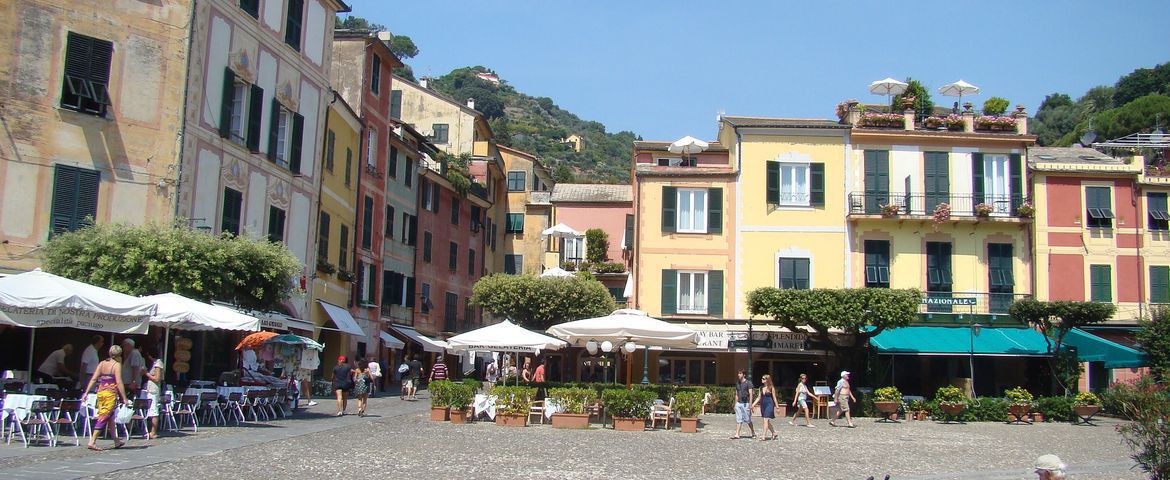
848 192 1034 221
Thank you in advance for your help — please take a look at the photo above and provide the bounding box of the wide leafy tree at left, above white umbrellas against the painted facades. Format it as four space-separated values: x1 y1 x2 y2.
43 224 302 310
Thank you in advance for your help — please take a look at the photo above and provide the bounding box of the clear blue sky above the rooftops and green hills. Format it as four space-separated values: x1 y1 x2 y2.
349 0 1170 139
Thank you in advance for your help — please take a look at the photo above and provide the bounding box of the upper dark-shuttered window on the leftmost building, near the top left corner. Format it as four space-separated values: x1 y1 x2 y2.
61 32 113 117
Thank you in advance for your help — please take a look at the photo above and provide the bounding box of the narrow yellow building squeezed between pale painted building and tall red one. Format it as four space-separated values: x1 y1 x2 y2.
309 92 364 370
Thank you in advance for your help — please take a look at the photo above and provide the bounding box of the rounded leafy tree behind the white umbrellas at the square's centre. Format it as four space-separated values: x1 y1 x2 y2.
472 274 617 330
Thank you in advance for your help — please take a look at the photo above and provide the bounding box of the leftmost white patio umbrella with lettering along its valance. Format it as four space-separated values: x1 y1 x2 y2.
0 268 157 379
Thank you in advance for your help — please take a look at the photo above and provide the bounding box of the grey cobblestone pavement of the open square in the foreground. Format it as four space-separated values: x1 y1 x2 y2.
0 397 1142 480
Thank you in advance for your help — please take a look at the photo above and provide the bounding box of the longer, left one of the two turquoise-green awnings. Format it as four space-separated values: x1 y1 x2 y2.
869 325 1048 357
